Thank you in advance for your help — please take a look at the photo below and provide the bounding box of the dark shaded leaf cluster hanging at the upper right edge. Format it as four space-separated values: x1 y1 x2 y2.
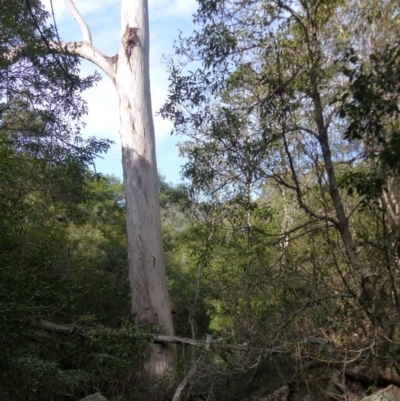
339 39 400 172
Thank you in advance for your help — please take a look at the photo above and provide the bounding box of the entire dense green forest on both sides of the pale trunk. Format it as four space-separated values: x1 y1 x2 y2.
0 0 400 401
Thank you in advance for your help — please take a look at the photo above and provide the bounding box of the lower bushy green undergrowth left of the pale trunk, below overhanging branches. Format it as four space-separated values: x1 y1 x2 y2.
0 168 155 400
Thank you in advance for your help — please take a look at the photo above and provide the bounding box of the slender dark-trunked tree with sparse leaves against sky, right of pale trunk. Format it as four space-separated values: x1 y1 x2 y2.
161 0 399 358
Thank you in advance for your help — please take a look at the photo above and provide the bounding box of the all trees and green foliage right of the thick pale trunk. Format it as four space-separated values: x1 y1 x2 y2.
161 0 400 399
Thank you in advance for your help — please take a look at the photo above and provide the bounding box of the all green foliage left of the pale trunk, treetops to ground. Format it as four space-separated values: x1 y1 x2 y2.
0 1 159 400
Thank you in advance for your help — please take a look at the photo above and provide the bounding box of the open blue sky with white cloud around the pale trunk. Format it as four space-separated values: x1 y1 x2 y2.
42 0 197 183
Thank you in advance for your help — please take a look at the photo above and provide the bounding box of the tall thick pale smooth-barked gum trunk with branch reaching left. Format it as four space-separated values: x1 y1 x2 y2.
55 0 176 377
